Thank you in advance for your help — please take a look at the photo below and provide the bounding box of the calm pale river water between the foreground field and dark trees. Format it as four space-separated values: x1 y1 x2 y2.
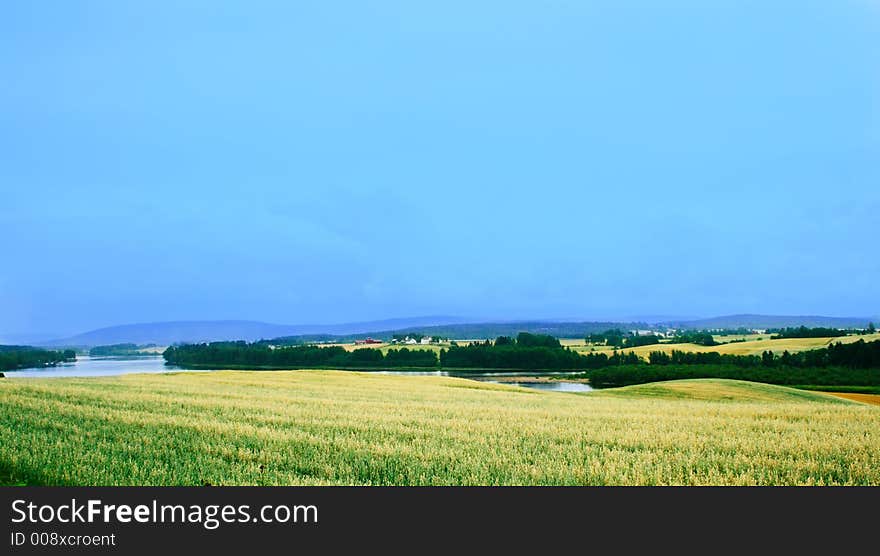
4 355 592 392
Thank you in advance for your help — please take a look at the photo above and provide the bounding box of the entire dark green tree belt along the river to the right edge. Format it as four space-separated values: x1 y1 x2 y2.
164 333 880 388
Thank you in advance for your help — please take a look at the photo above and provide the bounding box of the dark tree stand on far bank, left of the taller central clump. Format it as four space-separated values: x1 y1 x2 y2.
163 342 437 369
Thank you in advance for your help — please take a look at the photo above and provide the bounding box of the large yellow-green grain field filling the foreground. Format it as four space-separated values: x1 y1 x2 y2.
0 371 880 485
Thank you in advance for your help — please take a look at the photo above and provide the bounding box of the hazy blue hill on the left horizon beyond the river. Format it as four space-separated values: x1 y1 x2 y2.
39 316 466 347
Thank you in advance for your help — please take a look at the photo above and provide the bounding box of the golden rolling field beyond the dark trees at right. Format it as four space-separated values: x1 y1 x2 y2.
572 334 880 358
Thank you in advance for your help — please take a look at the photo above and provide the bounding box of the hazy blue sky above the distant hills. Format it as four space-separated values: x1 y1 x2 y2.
0 0 880 333
